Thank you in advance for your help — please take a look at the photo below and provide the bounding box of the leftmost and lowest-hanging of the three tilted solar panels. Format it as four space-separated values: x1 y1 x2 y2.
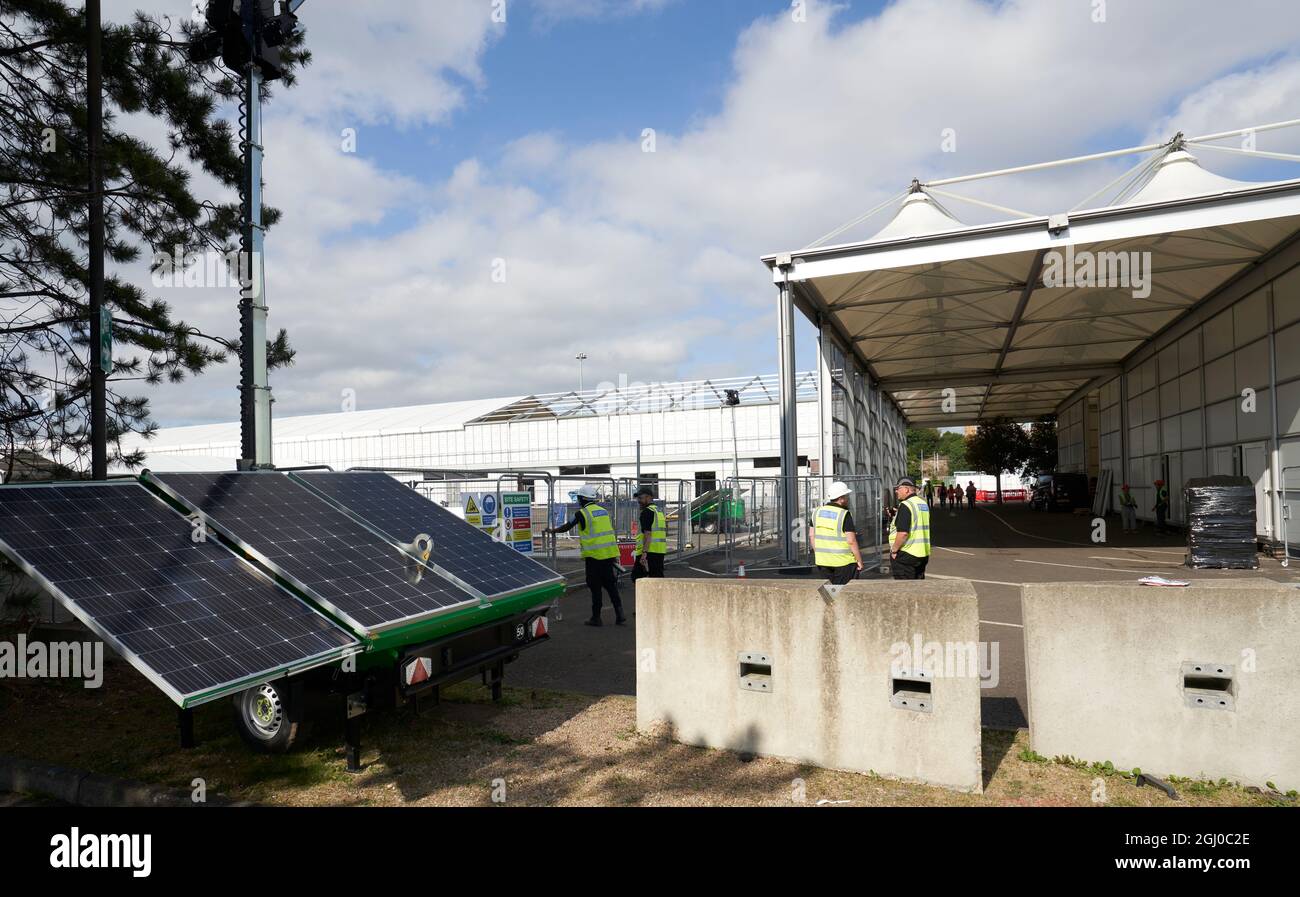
0 480 358 707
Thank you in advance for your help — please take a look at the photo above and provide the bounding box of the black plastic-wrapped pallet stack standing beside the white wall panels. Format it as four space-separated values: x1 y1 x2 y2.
1183 477 1260 569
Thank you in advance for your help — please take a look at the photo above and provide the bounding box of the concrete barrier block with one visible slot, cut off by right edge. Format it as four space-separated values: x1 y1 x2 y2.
1022 580 1300 790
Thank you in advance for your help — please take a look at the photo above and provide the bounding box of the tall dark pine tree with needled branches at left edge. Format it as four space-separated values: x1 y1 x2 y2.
0 0 299 467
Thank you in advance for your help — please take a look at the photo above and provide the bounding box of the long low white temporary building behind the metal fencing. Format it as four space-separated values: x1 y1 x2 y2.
126 373 883 481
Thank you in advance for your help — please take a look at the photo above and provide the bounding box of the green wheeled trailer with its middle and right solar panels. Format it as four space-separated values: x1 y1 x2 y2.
142 471 564 770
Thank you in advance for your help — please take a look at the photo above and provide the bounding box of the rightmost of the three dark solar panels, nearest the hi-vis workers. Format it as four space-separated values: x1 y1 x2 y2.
290 471 560 598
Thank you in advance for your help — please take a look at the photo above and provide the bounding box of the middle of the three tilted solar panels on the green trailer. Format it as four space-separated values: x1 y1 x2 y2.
146 471 480 634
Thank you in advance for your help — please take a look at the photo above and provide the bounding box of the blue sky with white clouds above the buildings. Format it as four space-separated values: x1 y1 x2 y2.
105 0 1300 426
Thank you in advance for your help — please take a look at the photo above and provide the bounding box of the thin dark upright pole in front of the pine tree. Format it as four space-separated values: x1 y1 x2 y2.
86 0 105 480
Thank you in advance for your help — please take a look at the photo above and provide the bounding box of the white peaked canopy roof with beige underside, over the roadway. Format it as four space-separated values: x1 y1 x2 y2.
763 150 1300 426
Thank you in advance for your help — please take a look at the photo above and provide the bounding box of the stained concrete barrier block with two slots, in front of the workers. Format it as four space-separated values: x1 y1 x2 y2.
636 579 982 792
